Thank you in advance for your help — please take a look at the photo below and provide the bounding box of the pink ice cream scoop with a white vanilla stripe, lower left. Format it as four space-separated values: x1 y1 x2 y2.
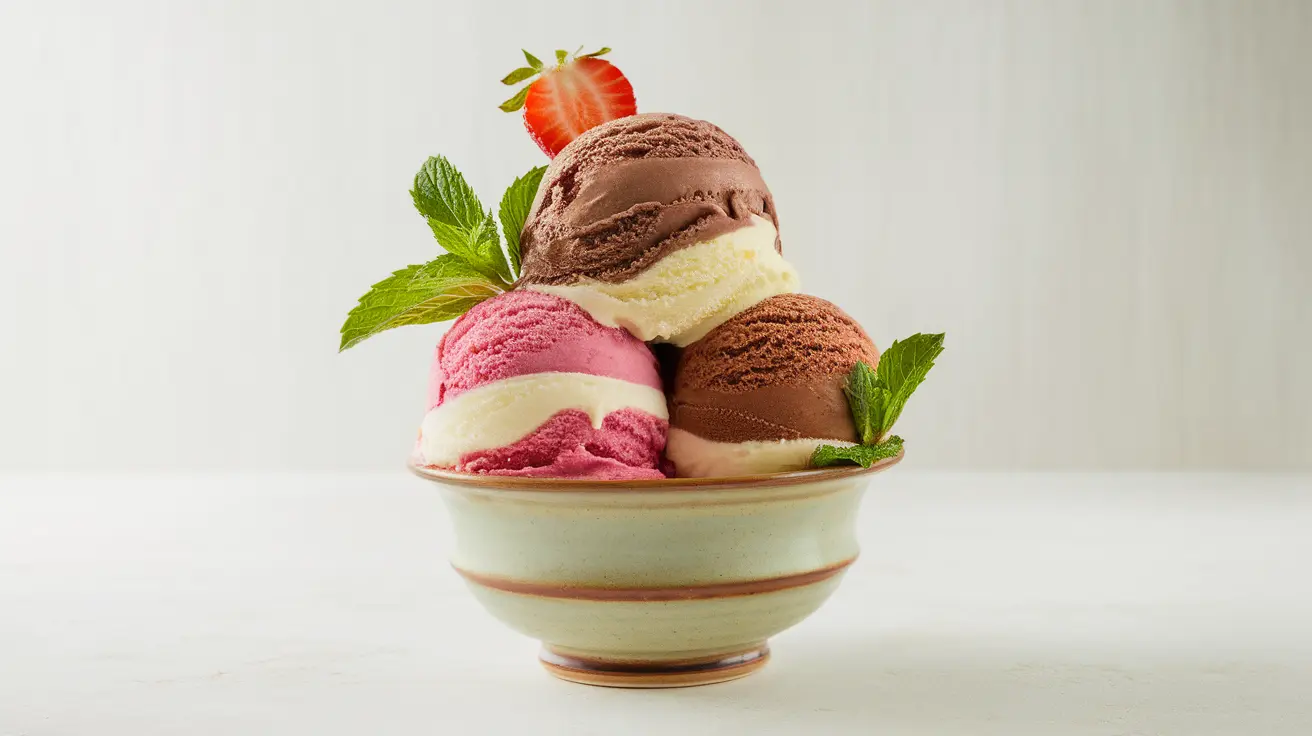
417 291 669 480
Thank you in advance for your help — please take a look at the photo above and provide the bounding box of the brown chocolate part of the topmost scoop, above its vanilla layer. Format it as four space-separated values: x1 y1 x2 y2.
520 113 779 285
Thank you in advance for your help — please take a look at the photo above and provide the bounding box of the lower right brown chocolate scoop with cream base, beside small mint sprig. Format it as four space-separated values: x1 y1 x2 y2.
666 294 879 478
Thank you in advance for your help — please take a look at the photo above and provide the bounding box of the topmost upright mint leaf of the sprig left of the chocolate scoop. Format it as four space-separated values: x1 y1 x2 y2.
411 156 513 285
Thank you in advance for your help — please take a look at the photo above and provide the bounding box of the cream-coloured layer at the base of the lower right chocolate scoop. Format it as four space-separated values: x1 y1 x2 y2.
665 428 851 478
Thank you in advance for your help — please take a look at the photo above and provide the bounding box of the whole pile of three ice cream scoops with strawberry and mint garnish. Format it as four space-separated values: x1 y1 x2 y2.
333 49 943 481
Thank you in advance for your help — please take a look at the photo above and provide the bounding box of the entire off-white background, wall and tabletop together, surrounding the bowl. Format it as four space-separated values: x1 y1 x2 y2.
0 0 1312 736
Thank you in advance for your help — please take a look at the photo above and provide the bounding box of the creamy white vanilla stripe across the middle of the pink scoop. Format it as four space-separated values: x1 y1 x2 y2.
419 373 669 466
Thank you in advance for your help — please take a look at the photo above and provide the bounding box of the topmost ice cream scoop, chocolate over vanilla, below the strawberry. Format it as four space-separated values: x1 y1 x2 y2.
520 113 798 345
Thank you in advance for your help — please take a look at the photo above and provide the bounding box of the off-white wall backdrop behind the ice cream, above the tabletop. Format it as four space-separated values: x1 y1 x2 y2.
0 0 1312 471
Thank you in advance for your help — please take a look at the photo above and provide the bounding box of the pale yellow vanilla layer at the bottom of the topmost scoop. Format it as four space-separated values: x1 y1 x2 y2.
529 215 798 348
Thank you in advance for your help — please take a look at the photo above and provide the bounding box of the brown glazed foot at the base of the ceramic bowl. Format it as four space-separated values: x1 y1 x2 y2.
539 642 770 687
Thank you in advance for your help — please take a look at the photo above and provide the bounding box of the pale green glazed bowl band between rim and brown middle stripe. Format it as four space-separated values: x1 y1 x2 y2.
443 478 865 588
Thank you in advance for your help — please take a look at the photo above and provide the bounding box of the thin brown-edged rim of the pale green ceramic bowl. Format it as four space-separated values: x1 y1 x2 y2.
405 449 907 493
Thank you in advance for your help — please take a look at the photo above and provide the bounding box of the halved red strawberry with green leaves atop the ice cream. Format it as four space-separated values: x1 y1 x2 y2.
501 49 638 157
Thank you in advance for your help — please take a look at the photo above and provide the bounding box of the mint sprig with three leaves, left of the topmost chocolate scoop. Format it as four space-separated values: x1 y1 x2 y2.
338 156 546 350
